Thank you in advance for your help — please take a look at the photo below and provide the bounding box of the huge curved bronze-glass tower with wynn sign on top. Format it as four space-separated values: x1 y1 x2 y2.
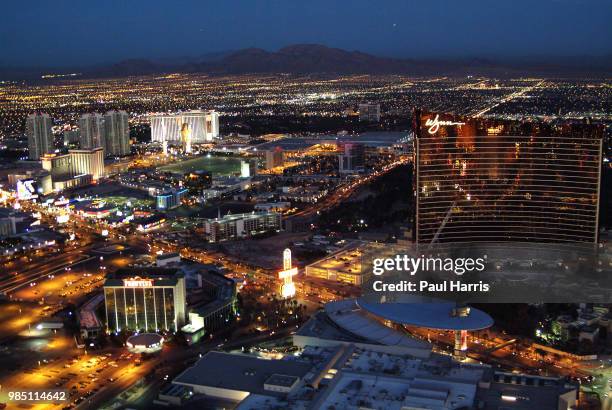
413 111 603 243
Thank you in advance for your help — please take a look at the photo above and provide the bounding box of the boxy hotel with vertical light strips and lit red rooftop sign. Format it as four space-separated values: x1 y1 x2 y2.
104 268 186 332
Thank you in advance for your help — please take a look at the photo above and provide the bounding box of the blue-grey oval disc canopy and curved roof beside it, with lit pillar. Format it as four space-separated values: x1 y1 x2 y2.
293 295 493 359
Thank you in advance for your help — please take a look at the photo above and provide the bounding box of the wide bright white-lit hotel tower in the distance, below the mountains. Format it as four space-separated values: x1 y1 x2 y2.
150 110 219 144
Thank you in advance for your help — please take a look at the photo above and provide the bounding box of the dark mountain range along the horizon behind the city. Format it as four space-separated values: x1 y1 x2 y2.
0 44 612 79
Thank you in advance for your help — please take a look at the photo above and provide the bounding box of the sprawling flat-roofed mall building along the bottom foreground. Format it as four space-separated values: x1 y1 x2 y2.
159 344 578 410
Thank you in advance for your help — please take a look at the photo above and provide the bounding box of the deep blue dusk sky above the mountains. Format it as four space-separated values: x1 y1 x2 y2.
0 0 612 66
